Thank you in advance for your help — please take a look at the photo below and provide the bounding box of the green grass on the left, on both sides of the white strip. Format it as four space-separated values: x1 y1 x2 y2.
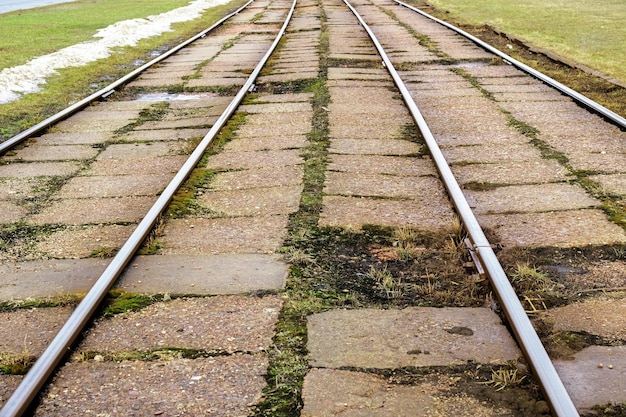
0 0 249 141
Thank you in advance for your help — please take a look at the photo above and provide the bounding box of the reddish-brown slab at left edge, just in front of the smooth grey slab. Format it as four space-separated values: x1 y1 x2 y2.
0 307 73 354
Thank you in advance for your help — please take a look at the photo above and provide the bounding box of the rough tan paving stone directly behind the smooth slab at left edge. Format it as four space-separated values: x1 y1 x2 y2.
35 224 135 259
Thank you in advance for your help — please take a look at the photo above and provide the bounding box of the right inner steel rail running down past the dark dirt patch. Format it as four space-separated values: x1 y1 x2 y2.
343 0 578 417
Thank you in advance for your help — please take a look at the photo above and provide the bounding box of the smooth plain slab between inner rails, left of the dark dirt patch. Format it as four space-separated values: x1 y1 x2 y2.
116 254 288 295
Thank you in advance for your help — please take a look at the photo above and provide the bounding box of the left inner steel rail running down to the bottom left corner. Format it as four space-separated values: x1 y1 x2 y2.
0 0 297 417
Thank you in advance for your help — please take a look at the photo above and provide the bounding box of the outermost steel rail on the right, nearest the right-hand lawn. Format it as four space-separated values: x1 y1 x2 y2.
393 0 626 129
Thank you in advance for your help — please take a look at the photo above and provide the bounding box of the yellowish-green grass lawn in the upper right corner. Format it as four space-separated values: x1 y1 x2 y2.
416 0 626 84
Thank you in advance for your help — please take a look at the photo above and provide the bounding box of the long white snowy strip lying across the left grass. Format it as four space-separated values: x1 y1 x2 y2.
0 0 229 104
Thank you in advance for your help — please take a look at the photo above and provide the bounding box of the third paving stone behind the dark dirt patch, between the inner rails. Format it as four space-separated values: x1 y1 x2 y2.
327 154 437 176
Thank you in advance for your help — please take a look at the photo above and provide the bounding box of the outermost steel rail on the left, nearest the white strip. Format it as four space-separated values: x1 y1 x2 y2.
0 0 254 154
